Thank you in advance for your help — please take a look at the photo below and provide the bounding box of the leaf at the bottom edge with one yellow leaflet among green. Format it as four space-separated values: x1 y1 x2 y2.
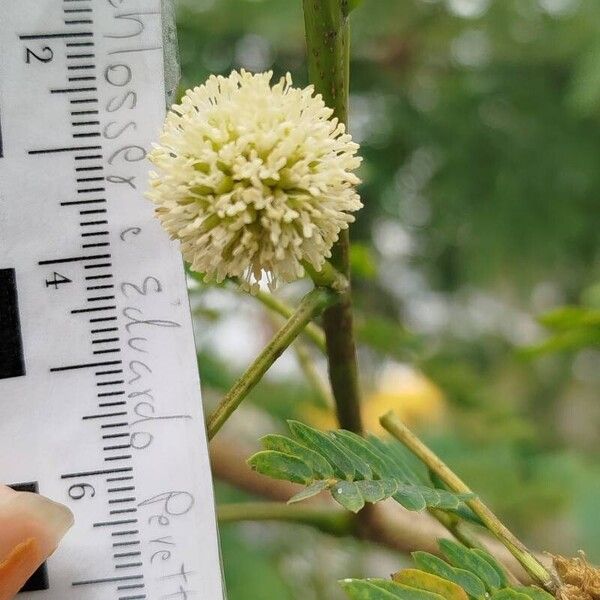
341 539 553 600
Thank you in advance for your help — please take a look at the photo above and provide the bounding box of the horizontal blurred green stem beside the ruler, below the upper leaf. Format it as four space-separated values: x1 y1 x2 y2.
217 502 355 535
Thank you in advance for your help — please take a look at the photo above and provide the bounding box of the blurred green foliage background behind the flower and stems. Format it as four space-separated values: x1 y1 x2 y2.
178 0 600 600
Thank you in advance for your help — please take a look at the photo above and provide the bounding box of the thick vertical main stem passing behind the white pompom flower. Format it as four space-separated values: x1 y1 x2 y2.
303 0 363 433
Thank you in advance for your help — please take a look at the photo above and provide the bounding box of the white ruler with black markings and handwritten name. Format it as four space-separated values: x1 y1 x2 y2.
0 0 223 600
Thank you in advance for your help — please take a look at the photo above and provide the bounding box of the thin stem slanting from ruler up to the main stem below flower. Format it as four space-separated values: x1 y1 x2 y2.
207 288 335 440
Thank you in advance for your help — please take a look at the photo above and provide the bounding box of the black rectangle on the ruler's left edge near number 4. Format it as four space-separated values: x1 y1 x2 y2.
0 269 25 379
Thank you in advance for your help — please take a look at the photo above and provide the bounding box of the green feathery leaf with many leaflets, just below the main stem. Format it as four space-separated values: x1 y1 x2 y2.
248 421 468 516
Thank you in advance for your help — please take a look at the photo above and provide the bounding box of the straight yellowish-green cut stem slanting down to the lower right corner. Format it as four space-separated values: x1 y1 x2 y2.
380 412 557 593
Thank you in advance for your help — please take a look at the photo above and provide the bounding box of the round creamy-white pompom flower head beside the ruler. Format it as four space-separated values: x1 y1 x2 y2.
148 71 362 289
